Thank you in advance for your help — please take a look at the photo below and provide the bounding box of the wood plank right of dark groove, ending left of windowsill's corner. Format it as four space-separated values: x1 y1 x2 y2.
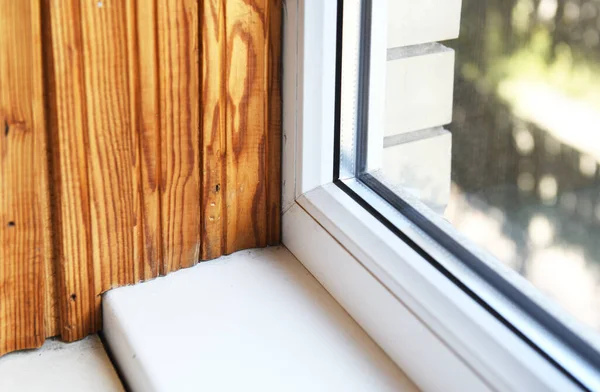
44 0 96 341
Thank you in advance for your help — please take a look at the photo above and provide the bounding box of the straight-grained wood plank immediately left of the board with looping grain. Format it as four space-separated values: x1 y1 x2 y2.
157 0 202 274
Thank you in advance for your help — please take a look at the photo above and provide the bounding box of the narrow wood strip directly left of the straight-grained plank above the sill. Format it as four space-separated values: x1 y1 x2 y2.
127 0 162 281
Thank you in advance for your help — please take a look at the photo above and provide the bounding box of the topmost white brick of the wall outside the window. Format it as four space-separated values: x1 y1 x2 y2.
388 0 462 48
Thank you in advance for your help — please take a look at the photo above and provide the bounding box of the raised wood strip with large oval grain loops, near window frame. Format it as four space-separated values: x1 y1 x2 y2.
223 0 268 253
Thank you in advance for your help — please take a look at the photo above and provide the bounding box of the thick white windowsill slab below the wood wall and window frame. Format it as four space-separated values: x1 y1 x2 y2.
103 247 416 391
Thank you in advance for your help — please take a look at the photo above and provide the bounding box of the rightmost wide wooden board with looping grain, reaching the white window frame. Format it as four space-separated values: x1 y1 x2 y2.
202 0 282 254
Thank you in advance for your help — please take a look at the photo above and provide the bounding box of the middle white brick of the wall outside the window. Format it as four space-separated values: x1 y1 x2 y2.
385 44 454 136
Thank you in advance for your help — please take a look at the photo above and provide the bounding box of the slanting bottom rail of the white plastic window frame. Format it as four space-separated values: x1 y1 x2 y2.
283 184 578 391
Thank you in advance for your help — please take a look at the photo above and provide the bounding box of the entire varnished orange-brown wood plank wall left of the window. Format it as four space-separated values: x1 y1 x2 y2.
0 0 282 355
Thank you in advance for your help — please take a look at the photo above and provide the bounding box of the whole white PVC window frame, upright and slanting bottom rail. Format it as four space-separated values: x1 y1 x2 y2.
282 0 600 391
